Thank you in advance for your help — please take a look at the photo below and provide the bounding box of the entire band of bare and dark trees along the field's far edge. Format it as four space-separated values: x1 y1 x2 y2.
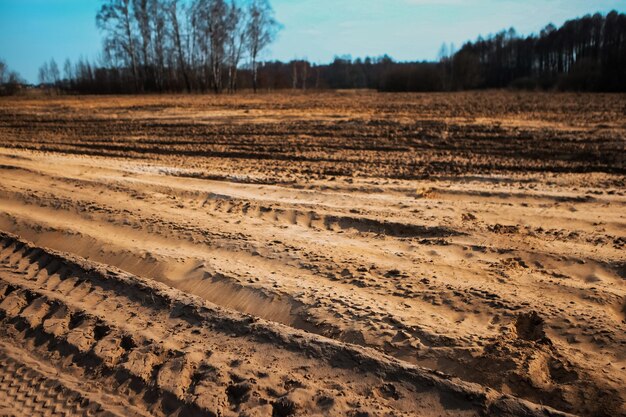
1 0 626 94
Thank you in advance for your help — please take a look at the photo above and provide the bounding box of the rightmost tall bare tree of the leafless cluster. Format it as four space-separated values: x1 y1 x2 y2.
246 0 279 93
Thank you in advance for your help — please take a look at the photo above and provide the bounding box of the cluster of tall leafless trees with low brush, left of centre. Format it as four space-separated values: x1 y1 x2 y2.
39 0 280 93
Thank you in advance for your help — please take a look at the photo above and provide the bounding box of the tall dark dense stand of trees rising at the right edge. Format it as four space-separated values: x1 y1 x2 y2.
446 11 626 91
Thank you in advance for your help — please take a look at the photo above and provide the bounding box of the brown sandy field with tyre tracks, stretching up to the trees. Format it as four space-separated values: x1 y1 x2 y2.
0 91 626 417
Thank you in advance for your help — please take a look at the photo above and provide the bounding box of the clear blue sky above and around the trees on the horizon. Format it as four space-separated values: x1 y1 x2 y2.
0 0 626 83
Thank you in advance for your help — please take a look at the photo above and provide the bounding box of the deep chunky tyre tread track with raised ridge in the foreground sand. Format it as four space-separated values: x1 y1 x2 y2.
0 233 558 416
